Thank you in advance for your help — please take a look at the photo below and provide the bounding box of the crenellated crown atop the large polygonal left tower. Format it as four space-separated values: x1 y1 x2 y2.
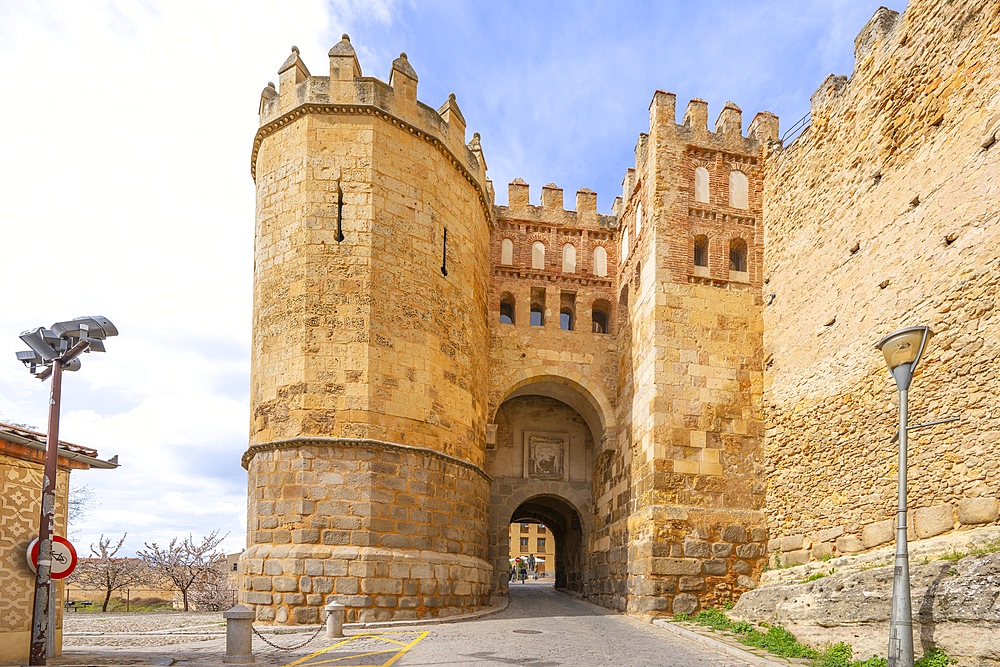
251 34 492 197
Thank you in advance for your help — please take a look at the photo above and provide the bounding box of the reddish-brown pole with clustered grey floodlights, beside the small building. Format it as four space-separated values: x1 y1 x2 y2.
17 316 118 666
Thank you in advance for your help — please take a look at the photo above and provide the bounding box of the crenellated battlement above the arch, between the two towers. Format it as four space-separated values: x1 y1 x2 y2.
494 178 617 229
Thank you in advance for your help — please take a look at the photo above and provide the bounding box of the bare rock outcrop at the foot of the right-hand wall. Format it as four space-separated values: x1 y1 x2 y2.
731 553 1000 667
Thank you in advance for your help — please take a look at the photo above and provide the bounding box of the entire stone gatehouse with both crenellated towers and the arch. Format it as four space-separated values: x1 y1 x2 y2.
246 36 777 624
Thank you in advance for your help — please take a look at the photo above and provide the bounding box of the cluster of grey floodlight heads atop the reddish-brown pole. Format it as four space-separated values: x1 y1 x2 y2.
17 315 118 380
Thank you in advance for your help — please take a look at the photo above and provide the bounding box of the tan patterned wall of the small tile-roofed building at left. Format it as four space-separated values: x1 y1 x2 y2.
0 443 69 662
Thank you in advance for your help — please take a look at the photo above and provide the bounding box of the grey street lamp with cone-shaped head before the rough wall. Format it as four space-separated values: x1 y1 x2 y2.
878 326 934 667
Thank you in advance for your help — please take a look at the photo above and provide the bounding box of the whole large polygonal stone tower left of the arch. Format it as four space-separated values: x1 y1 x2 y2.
241 35 492 623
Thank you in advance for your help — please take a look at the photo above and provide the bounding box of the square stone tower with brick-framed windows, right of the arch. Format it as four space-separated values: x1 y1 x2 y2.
618 93 776 613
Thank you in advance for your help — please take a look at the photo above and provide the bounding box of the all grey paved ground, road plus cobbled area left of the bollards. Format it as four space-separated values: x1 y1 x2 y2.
35 582 752 667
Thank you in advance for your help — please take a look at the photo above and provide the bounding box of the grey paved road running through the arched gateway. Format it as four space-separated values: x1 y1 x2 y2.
296 583 747 667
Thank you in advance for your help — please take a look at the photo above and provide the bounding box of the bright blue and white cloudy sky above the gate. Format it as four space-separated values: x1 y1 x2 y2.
0 0 905 550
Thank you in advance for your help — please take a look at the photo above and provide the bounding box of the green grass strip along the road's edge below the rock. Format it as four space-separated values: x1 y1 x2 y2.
674 612 956 667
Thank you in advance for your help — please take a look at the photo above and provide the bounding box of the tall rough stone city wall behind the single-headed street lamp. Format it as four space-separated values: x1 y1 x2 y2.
764 0 1000 564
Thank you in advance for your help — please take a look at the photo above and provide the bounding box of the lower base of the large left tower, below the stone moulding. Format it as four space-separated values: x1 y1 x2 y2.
240 442 493 624
